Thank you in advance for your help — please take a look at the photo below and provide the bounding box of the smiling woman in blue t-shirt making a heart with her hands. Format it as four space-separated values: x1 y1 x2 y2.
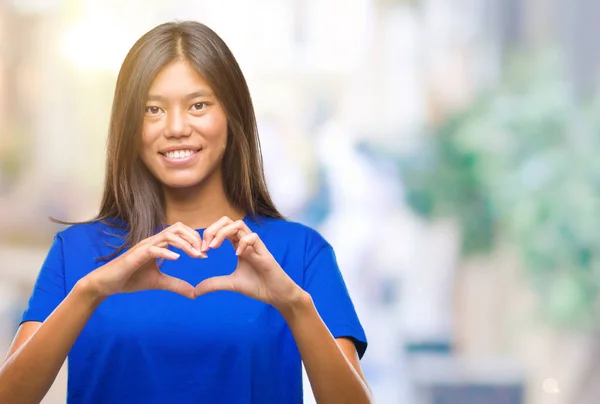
0 22 372 404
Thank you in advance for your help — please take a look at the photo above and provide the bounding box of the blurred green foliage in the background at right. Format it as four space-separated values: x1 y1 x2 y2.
401 50 600 328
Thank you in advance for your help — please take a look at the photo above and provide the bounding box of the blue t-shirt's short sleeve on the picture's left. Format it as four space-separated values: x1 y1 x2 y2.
21 234 66 323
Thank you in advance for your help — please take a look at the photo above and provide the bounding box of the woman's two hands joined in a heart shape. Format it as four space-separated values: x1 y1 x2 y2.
85 217 303 308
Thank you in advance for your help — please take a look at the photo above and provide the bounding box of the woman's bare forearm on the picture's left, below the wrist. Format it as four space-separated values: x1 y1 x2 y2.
0 283 101 404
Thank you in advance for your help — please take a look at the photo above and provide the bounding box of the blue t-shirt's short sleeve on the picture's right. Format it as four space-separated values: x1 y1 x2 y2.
304 244 367 358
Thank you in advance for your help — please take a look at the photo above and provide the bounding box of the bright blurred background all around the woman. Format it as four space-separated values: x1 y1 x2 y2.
0 0 600 404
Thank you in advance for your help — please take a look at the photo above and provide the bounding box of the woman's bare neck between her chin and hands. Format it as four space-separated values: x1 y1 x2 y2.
164 169 246 229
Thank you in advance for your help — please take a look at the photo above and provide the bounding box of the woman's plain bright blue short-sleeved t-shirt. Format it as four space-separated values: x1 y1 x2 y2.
22 218 367 404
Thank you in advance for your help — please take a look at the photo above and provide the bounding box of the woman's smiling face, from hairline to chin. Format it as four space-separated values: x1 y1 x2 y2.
140 60 227 188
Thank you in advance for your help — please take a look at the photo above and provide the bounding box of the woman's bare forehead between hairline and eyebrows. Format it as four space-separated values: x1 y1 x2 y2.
149 60 213 97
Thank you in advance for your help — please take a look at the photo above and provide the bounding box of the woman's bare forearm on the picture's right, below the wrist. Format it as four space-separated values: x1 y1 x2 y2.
280 293 372 404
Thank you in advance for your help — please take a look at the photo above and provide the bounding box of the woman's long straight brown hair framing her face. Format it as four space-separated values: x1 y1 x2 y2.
56 21 283 256
